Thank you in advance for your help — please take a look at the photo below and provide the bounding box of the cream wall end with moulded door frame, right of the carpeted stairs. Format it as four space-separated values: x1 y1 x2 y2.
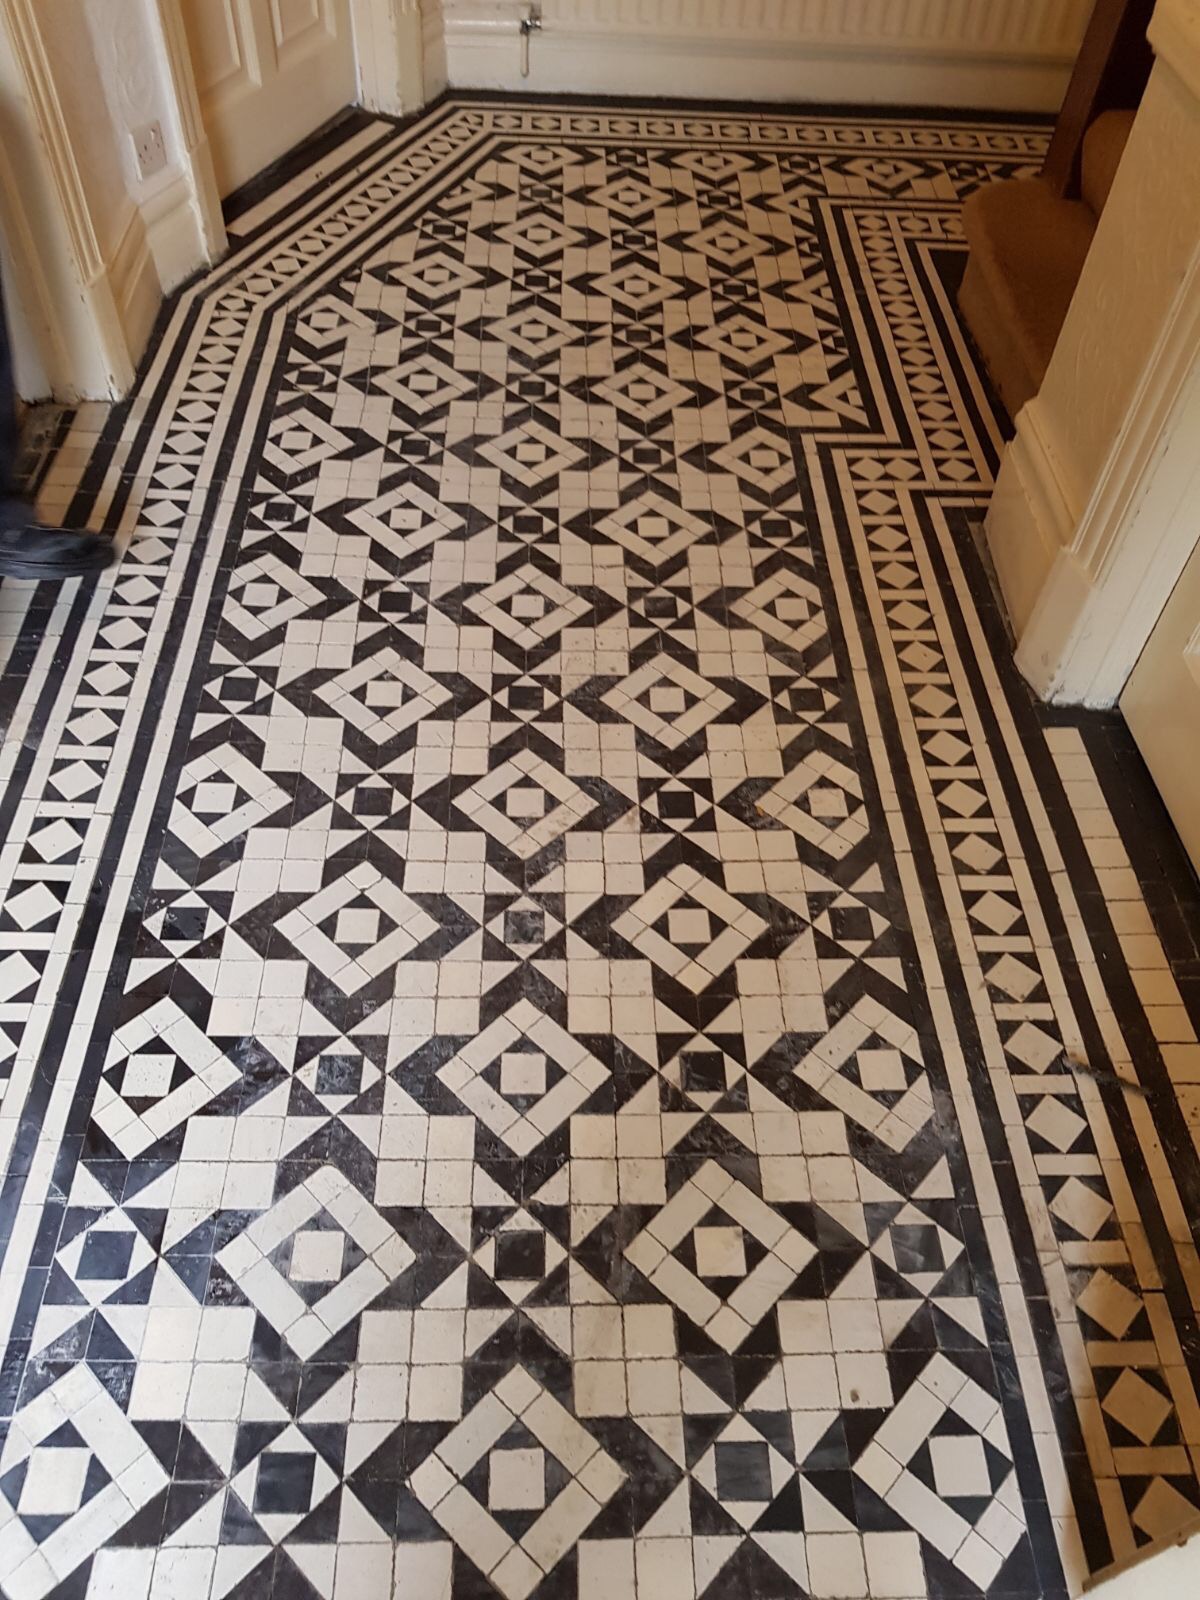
987 0 1200 706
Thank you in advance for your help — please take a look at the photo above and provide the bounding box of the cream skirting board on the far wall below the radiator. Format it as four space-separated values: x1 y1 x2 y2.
445 22 1070 112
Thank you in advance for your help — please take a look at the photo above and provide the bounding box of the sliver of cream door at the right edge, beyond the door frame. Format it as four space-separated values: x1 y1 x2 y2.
1122 531 1200 870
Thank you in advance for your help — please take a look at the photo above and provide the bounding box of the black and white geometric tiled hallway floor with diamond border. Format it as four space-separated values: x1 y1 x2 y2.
0 98 1200 1600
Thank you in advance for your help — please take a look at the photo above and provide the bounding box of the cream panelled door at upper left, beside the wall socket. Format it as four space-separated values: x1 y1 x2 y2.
182 0 357 195
